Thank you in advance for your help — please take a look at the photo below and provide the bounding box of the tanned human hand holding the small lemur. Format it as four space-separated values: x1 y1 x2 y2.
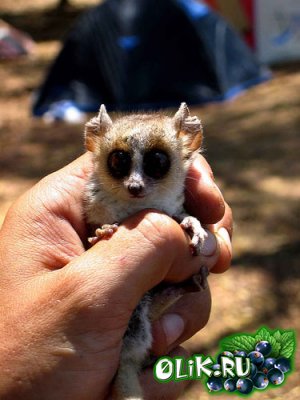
0 154 231 400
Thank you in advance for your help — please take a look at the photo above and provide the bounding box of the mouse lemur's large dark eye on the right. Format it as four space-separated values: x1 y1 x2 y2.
143 149 171 179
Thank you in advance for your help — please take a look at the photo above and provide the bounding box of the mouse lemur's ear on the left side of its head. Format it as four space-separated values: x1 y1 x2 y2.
84 104 112 151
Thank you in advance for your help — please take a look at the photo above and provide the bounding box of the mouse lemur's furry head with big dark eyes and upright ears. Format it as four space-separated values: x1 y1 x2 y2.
85 103 202 201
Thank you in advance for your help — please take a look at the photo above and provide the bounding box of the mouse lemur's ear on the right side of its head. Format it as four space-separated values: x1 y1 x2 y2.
172 103 203 152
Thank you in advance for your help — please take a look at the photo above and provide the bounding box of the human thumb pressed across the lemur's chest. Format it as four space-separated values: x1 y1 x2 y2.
64 210 200 318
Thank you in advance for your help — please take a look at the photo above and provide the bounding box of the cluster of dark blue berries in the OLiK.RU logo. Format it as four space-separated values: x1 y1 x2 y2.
207 340 291 394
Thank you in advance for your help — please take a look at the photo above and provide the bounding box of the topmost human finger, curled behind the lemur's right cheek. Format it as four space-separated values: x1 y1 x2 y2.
185 155 225 224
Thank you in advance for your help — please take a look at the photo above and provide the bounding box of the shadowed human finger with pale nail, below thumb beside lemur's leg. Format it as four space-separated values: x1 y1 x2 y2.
152 287 211 355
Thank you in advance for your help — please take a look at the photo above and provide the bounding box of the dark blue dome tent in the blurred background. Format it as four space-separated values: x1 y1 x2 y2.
33 0 270 116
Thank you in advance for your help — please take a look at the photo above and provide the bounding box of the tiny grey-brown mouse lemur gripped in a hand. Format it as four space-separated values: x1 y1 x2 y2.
85 103 207 399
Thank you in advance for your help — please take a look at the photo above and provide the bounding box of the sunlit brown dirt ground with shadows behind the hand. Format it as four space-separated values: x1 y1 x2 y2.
0 0 300 400
